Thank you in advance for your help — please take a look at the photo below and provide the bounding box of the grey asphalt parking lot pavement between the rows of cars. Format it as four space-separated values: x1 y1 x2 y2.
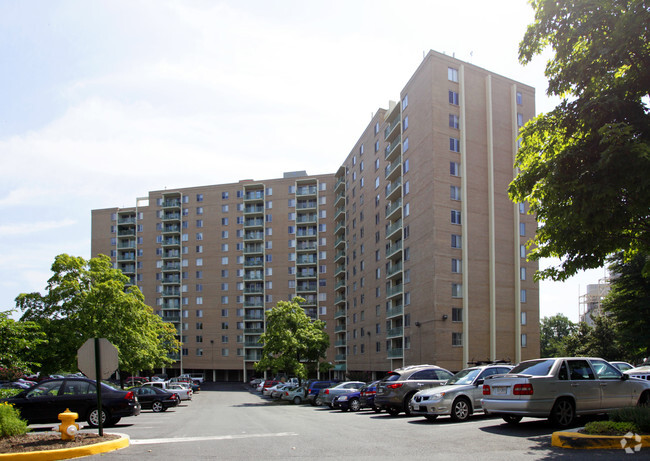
29 383 636 460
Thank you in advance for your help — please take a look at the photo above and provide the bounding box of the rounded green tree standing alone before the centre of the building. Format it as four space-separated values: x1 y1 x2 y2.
255 297 329 380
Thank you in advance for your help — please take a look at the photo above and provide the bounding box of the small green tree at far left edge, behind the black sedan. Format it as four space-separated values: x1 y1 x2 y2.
0 311 47 381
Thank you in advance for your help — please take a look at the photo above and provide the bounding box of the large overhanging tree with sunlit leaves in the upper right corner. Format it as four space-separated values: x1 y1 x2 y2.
509 0 650 280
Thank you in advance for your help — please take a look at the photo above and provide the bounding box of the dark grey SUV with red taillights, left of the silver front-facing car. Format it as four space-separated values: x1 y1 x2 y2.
375 365 453 416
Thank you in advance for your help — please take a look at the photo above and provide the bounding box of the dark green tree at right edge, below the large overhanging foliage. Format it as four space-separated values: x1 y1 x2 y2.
602 253 650 363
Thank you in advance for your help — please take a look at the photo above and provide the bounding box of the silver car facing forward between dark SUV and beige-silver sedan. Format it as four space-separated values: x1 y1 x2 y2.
410 364 512 421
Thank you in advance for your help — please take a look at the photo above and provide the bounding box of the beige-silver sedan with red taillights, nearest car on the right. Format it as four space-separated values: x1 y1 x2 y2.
483 357 650 427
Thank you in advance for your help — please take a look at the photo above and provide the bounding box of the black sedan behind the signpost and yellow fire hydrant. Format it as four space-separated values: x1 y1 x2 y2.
3 378 140 427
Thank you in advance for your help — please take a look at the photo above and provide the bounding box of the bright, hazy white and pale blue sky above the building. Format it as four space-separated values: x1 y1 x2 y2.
0 0 604 320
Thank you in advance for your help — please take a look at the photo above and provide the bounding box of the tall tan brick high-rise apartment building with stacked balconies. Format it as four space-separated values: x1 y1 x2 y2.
92 51 539 380
